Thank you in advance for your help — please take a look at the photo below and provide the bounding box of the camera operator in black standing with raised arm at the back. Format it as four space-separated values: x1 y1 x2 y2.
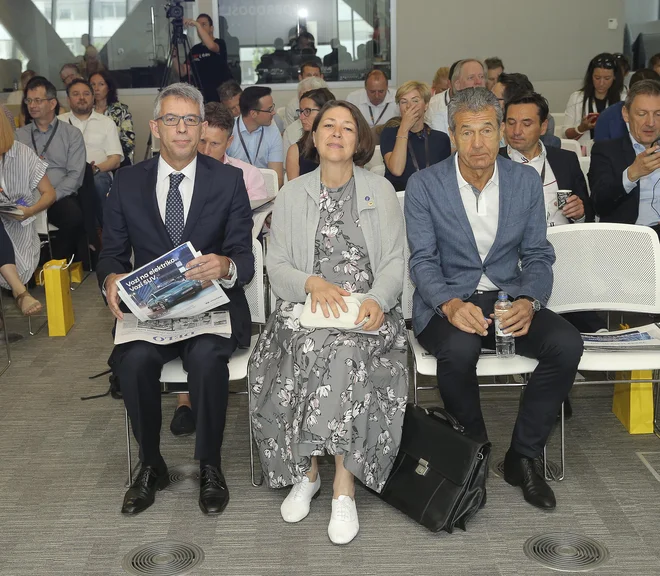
174 14 233 103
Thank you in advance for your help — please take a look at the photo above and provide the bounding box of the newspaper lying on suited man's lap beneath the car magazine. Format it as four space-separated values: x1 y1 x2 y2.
115 310 231 344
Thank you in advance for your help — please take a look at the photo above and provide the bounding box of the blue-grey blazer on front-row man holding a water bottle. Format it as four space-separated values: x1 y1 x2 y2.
404 154 555 335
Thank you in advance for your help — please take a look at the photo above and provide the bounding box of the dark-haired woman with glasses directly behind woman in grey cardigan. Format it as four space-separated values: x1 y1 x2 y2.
286 88 335 180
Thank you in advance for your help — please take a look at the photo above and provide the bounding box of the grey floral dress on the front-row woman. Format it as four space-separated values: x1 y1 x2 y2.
249 179 408 492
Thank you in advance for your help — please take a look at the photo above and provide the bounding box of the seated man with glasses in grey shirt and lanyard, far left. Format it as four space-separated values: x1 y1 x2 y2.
16 76 86 261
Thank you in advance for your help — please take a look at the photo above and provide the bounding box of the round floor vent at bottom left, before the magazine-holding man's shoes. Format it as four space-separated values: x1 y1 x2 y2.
122 540 204 576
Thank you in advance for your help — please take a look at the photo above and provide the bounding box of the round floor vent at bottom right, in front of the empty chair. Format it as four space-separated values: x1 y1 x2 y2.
523 532 610 572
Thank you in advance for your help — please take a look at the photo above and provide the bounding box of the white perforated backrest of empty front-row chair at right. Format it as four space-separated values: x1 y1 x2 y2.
548 223 660 314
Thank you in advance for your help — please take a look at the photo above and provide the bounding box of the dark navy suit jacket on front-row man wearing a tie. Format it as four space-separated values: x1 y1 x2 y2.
96 154 254 347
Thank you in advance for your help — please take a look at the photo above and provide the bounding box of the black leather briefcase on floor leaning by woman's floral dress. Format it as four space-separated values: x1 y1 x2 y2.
380 403 491 534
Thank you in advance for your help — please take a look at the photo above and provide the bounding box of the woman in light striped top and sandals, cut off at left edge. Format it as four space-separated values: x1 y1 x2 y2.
0 114 55 316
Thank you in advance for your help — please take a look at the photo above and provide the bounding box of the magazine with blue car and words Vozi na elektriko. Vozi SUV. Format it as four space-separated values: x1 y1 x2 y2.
117 242 229 322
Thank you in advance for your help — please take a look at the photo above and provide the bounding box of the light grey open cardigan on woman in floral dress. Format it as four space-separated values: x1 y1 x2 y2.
266 166 406 312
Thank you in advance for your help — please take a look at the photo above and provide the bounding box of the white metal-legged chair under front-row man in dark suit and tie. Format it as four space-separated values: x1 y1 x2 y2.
124 239 266 486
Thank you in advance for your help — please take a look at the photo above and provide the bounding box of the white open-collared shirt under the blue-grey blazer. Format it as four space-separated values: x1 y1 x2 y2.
454 154 500 292
